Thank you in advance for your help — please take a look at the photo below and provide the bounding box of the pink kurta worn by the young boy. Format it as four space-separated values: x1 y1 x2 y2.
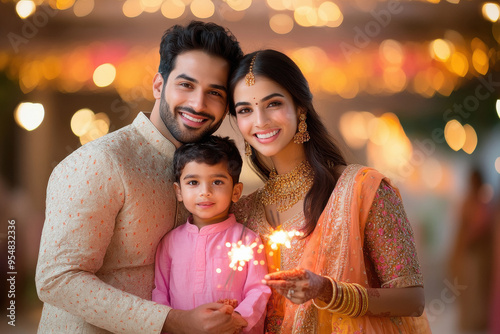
153 214 271 334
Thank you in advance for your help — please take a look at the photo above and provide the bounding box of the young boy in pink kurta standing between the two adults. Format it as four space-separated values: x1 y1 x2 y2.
153 136 271 334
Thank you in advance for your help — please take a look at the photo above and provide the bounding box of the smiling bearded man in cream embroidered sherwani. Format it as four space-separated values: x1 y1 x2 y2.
36 22 246 333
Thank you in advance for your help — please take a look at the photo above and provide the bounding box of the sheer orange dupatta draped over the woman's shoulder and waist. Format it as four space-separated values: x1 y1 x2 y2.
282 165 430 334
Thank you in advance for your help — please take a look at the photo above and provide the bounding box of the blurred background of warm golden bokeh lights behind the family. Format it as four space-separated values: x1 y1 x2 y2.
0 0 500 333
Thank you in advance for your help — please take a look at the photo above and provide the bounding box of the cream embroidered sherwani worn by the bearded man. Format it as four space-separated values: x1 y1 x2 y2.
36 113 177 334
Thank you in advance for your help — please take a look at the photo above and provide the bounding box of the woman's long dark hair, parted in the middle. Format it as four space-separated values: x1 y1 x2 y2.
229 50 346 236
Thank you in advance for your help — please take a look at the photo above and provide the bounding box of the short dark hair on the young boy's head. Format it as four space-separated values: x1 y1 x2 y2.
173 136 243 185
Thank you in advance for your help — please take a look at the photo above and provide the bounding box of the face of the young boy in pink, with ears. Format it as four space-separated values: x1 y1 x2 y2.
174 161 243 228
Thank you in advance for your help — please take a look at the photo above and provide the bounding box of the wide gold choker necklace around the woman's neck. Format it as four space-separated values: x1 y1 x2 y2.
261 160 314 212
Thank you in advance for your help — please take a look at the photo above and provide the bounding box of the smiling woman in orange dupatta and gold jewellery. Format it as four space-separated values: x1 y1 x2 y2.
230 50 430 333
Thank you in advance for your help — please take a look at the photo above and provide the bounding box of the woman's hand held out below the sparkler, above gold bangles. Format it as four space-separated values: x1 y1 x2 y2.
262 268 333 304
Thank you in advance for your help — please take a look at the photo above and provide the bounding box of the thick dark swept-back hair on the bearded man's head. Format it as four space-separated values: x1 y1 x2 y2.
158 21 243 82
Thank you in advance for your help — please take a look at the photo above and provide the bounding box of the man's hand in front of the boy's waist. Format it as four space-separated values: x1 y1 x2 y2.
163 303 247 334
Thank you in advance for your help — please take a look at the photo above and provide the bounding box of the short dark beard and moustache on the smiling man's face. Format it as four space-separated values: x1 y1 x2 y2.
160 96 224 144
